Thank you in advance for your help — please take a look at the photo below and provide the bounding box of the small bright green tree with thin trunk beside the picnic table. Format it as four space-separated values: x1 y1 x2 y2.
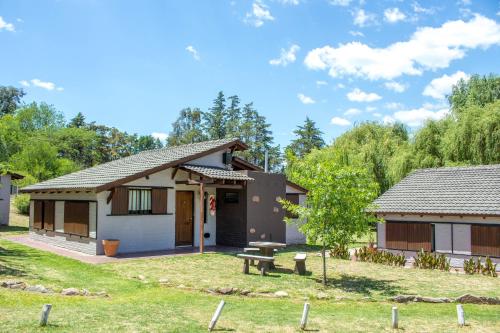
280 155 378 286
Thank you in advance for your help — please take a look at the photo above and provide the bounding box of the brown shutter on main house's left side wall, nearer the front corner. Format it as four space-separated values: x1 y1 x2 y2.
64 201 89 237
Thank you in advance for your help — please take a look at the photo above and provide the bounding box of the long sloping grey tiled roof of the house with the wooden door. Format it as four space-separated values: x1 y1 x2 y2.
21 139 247 192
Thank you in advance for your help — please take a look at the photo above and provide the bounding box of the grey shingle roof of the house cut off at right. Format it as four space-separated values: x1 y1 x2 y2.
374 164 500 216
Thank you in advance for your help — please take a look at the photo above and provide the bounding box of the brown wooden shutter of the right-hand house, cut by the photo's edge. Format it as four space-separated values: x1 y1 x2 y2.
471 224 500 257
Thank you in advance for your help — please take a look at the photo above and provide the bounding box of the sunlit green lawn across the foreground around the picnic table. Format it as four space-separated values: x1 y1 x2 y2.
0 234 500 332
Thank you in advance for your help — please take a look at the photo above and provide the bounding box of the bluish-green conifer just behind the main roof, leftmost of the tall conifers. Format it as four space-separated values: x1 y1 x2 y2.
167 108 206 146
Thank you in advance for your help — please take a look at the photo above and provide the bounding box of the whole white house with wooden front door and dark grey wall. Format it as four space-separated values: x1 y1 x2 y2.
21 139 306 254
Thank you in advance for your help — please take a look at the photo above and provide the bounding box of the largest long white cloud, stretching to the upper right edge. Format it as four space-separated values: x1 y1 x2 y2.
304 14 500 80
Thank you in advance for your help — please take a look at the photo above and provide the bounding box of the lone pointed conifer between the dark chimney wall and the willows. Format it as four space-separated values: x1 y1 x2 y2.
286 117 325 157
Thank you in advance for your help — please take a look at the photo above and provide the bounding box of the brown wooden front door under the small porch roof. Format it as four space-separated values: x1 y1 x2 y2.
175 191 194 246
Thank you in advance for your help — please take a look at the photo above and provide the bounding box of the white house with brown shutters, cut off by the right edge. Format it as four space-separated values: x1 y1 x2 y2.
374 165 500 266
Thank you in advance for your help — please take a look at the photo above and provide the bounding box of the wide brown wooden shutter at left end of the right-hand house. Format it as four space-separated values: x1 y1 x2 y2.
386 222 432 251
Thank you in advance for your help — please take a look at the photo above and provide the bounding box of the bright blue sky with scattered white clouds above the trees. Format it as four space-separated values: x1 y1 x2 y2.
0 0 500 146
